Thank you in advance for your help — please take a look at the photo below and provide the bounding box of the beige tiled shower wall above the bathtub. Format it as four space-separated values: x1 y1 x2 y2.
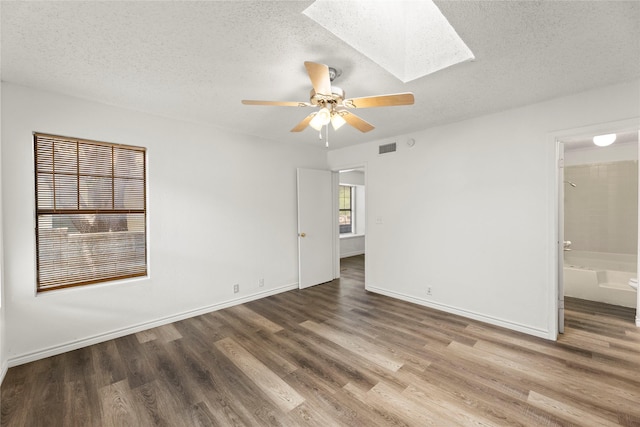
565 160 638 254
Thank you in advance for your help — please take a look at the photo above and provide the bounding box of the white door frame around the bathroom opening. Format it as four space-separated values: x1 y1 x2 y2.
547 117 640 340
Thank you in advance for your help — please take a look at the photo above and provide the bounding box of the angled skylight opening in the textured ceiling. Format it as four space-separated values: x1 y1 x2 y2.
302 0 475 83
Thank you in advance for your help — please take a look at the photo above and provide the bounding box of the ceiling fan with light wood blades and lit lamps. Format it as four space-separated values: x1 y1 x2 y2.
242 61 414 132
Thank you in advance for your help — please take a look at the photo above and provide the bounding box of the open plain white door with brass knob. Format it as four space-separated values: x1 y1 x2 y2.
298 169 337 289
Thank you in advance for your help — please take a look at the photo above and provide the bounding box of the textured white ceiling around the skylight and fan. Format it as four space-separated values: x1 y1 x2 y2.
0 1 640 147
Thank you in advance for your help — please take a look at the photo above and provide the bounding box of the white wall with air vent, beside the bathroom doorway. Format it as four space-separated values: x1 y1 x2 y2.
329 81 640 339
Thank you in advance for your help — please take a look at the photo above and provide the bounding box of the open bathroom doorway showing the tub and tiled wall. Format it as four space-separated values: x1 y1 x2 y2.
557 122 640 333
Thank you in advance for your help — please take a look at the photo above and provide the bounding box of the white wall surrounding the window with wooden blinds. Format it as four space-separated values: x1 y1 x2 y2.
2 84 327 365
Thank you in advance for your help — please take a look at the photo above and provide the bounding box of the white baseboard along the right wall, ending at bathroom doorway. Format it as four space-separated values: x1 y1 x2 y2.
366 286 556 340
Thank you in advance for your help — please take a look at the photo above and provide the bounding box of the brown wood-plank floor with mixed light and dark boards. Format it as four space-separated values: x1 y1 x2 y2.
1 256 640 427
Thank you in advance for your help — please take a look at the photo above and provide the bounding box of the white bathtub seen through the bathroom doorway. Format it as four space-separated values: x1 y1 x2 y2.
564 250 638 307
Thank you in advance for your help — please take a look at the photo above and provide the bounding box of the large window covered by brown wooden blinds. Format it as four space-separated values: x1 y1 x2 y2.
34 133 147 292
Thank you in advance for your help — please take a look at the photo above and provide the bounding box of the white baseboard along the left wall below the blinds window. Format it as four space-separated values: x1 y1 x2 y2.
8 283 298 370
